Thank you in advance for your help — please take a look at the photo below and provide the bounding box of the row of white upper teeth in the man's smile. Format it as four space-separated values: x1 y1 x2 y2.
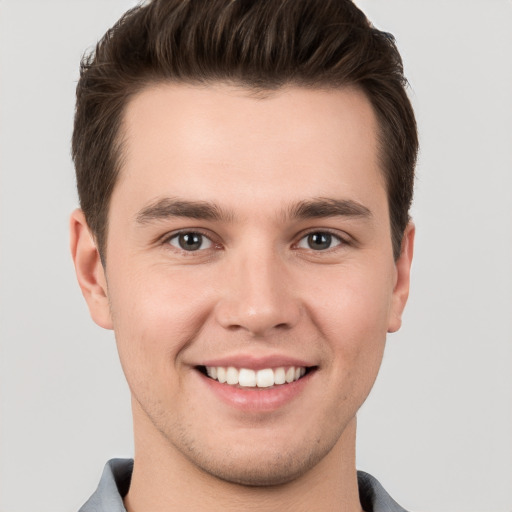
206 366 306 388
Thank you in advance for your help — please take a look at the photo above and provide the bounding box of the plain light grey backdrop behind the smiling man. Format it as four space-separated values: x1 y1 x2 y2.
0 0 512 512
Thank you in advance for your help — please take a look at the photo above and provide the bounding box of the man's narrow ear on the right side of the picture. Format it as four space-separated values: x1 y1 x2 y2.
388 222 415 332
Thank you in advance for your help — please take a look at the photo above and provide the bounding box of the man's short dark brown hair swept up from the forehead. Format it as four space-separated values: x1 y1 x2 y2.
72 0 418 261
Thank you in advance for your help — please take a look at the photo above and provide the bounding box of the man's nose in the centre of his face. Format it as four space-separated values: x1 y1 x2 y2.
216 250 301 337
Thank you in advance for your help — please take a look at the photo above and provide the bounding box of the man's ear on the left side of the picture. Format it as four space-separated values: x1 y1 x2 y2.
69 209 112 329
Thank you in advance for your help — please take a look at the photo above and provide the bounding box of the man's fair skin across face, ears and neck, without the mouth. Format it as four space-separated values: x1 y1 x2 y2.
71 84 414 512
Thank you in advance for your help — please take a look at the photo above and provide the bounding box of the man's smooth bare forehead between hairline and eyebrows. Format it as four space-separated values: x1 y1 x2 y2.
113 84 385 218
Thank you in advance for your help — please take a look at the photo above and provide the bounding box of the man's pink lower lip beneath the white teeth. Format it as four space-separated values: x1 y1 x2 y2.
198 371 315 412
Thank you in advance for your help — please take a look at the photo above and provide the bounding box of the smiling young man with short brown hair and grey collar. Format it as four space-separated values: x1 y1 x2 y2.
71 0 418 512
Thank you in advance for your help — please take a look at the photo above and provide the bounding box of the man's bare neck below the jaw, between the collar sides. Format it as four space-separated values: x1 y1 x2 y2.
124 406 362 512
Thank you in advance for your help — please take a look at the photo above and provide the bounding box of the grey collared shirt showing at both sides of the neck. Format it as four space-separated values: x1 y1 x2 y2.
79 459 407 512
